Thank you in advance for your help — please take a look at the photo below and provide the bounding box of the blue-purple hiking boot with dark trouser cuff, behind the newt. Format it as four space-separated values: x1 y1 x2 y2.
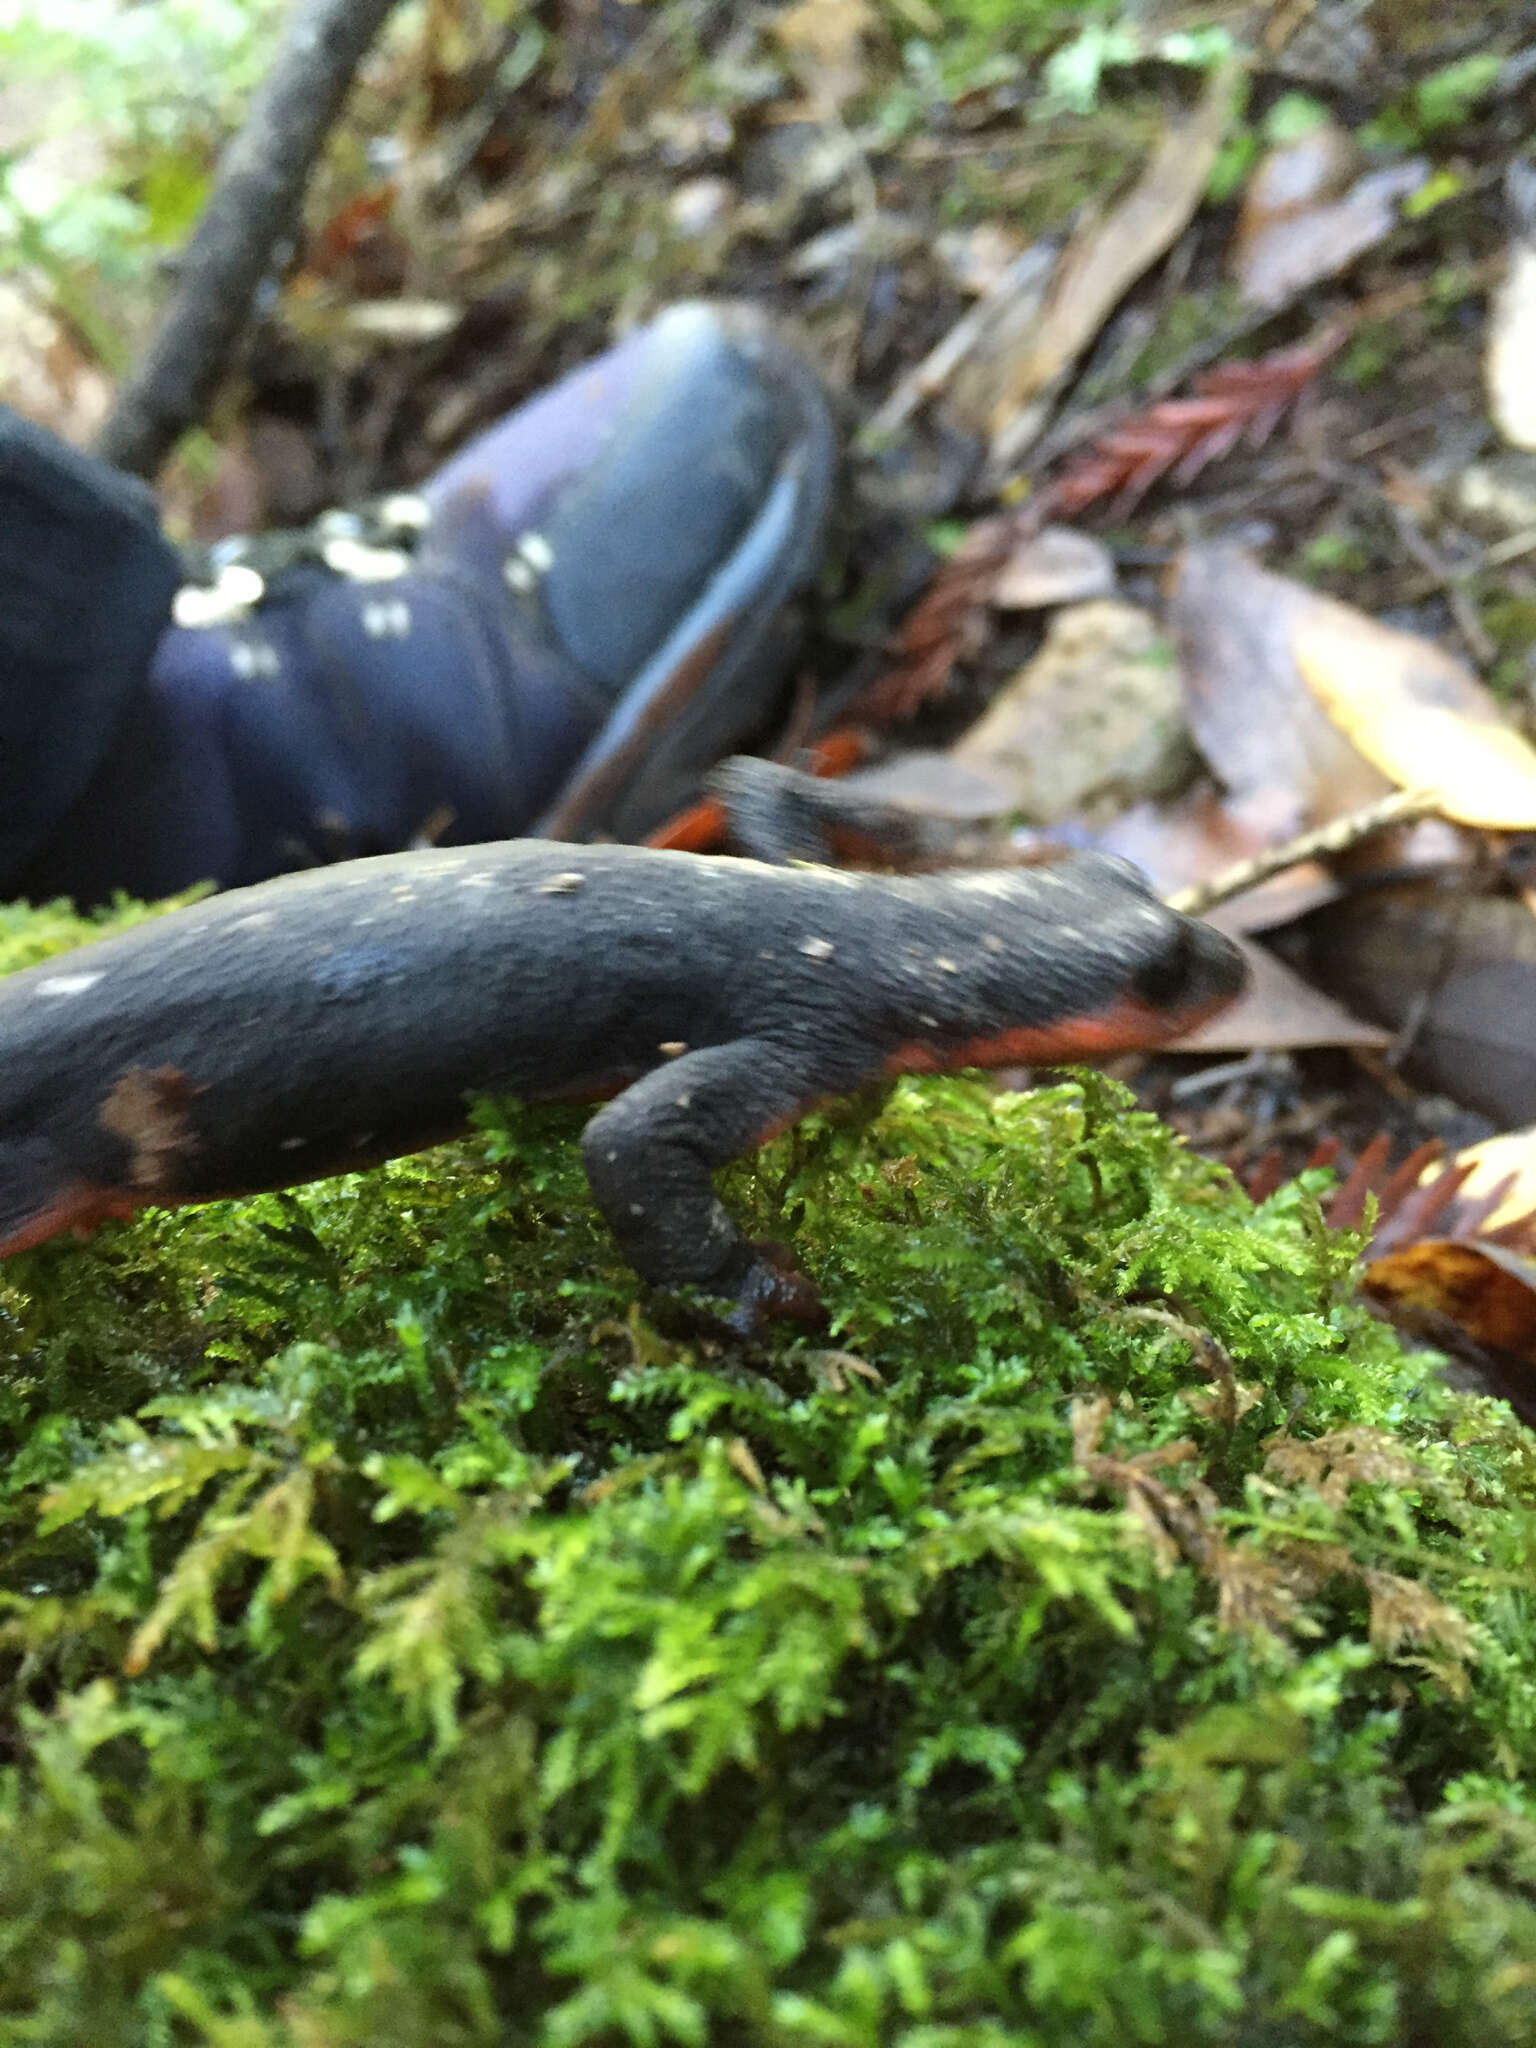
0 305 836 901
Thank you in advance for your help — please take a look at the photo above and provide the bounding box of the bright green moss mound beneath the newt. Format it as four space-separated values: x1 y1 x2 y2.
0 913 1536 2048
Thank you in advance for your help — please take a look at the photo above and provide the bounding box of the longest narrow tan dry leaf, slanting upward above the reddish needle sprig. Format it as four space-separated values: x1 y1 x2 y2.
989 63 1239 463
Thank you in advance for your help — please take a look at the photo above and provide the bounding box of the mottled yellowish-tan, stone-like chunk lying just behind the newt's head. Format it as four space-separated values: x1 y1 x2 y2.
950 598 1192 825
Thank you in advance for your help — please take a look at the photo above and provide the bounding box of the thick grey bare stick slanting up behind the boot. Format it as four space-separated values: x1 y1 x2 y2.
96 0 395 477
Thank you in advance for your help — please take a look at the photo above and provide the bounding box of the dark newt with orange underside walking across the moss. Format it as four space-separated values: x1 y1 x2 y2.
0 840 1243 1313
